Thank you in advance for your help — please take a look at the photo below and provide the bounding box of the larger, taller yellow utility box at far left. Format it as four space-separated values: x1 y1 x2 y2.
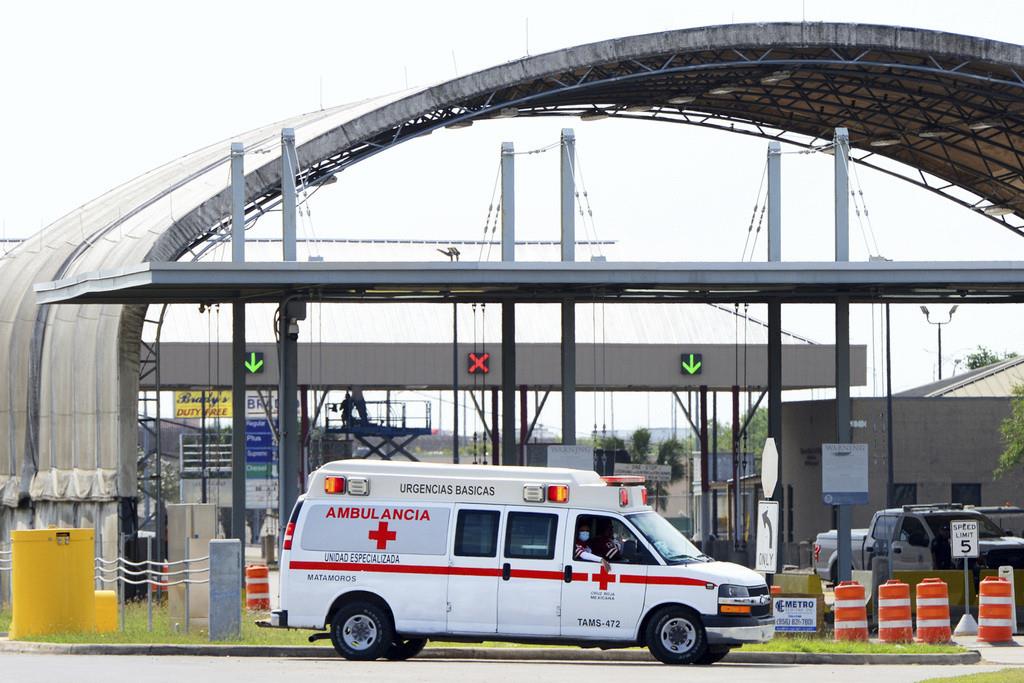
10 528 96 640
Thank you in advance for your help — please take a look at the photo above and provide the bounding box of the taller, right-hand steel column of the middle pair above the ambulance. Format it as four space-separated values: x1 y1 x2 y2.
561 128 575 443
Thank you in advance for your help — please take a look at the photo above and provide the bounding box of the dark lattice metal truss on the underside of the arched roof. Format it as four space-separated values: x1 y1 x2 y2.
182 40 1024 258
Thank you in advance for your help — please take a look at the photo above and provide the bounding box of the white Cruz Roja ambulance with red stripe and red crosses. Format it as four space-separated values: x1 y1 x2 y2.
266 460 774 664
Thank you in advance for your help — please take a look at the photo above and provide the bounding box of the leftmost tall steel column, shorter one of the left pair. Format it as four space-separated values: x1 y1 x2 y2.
230 142 248 554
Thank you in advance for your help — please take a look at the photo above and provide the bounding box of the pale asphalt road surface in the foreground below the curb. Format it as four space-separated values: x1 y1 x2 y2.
0 654 999 683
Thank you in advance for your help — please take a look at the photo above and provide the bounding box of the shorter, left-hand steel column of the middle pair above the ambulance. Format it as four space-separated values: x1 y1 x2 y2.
503 142 518 465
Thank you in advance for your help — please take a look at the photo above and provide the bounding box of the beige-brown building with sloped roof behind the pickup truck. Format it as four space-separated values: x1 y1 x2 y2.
781 358 1024 562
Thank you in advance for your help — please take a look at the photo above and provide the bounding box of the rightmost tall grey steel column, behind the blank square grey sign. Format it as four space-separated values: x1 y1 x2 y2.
835 128 853 581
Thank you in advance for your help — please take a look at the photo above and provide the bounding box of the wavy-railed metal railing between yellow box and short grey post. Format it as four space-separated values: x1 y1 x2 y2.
93 539 210 633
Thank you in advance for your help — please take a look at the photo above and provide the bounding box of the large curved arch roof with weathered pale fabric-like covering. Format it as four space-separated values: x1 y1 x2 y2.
0 24 1024 505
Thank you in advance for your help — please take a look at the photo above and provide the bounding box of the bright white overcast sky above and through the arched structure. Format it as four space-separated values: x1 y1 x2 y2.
0 0 1024 438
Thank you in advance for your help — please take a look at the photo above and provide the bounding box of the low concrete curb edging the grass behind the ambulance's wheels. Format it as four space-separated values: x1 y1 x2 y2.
0 640 981 666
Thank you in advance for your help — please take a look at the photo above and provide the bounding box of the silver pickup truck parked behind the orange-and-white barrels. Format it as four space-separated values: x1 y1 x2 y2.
813 504 1024 582
